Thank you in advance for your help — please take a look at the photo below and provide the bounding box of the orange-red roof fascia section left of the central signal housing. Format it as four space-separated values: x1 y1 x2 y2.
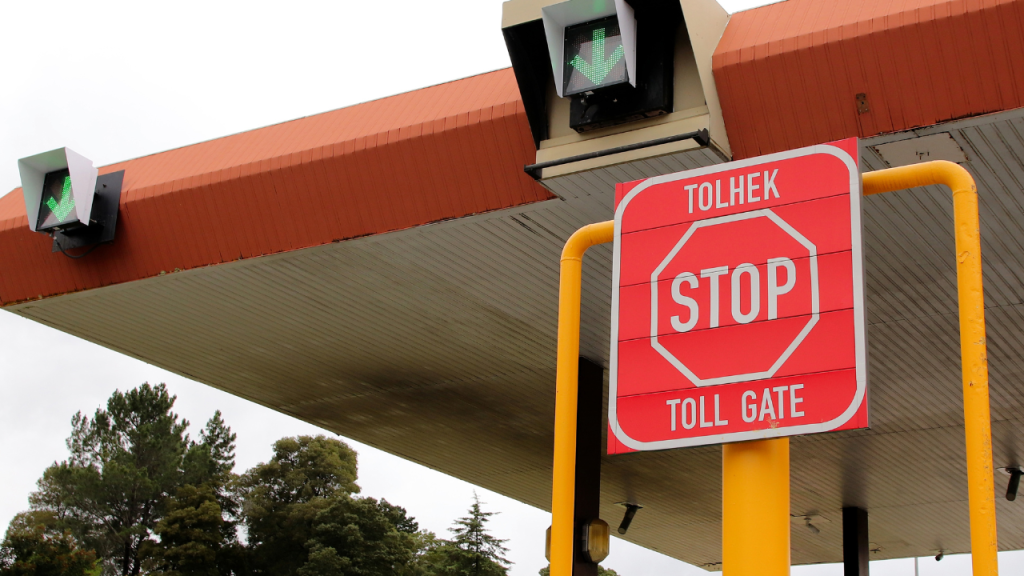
0 70 553 304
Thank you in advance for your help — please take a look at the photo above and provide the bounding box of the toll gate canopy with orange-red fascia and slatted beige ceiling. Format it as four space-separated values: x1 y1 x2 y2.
6 0 1024 569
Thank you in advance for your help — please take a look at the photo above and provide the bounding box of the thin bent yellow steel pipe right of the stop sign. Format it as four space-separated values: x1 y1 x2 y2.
862 161 998 576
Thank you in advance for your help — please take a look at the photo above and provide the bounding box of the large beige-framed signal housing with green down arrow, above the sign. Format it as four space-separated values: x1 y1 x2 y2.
502 0 731 182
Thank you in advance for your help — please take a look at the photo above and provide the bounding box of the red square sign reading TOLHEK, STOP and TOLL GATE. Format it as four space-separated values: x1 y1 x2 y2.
608 138 867 453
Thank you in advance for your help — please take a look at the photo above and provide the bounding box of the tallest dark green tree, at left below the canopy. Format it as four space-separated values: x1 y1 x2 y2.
17 383 238 576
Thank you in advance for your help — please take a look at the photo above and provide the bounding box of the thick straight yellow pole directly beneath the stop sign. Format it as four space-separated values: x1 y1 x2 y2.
722 438 790 576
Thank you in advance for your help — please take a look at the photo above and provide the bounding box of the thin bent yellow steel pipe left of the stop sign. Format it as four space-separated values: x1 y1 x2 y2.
551 220 615 576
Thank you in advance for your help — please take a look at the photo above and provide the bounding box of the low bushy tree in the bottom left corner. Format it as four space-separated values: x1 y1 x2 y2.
0 512 99 576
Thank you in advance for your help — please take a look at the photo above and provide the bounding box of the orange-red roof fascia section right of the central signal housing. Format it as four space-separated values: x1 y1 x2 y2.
713 0 1024 159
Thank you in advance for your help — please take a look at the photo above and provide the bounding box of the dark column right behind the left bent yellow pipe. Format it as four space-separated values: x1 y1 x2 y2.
572 358 604 576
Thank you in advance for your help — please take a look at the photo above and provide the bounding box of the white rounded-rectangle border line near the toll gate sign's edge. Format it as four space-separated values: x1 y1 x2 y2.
608 139 867 451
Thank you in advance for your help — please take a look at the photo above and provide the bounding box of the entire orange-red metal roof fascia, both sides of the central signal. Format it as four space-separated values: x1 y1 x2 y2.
0 0 1024 305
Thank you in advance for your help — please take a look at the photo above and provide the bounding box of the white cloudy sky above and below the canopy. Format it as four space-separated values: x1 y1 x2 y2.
0 0 1024 576
